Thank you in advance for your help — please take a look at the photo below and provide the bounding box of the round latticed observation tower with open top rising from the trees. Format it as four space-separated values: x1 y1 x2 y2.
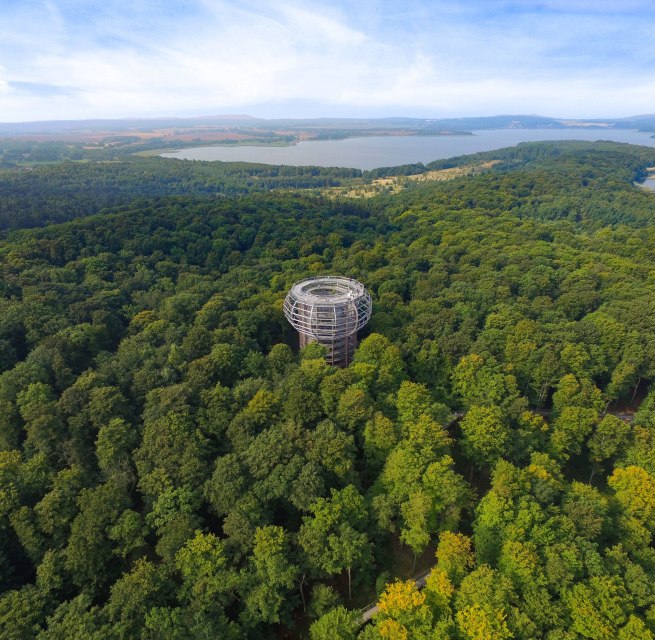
284 276 372 367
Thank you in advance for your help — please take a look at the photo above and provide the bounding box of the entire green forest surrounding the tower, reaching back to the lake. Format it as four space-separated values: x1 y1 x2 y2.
0 143 655 640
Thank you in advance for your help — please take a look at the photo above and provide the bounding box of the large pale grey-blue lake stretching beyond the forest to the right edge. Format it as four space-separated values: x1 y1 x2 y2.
161 129 655 169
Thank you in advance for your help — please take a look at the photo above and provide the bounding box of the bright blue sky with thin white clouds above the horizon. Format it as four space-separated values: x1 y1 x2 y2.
0 0 655 122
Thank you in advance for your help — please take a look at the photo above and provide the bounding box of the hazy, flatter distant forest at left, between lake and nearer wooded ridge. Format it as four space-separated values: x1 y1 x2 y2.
0 152 362 234
